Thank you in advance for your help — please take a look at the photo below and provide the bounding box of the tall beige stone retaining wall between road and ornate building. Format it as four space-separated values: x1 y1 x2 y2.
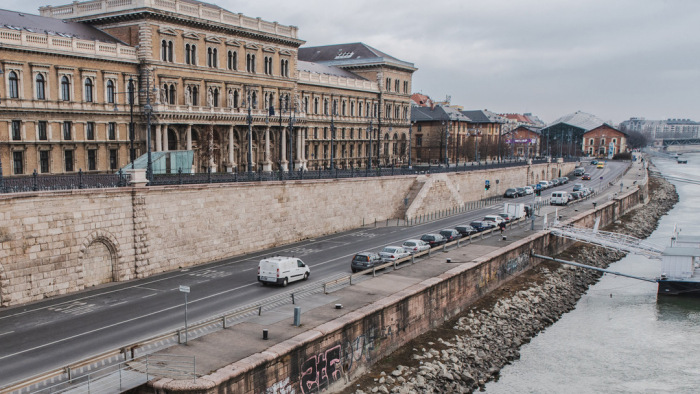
0 163 576 306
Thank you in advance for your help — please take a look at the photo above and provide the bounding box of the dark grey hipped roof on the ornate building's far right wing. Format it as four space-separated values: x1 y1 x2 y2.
298 42 415 69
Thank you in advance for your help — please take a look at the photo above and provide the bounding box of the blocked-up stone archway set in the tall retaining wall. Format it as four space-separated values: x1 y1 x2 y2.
78 230 123 288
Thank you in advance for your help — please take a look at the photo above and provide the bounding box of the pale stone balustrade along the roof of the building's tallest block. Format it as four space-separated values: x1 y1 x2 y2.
39 0 298 39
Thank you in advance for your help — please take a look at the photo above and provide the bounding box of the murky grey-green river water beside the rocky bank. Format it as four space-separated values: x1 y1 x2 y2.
485 154 700 394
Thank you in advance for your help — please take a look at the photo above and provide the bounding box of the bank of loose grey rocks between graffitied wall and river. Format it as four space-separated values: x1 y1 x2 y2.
346 174 678 394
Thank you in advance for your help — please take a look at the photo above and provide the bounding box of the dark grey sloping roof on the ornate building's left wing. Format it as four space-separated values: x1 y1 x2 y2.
0 9 122 43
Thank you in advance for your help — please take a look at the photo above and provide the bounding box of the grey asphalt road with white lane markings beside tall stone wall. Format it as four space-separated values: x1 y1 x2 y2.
0 163 627 387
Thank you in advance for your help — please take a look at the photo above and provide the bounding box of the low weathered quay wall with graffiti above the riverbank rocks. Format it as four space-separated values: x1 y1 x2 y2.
149 185 646 394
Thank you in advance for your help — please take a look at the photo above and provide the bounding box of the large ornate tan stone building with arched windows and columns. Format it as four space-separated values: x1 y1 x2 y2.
0 0 416 175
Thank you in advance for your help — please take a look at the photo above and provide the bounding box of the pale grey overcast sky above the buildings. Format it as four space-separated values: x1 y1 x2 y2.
5 0 700 123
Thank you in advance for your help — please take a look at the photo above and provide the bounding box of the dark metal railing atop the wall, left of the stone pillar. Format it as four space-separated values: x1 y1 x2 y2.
0 170 131 193
